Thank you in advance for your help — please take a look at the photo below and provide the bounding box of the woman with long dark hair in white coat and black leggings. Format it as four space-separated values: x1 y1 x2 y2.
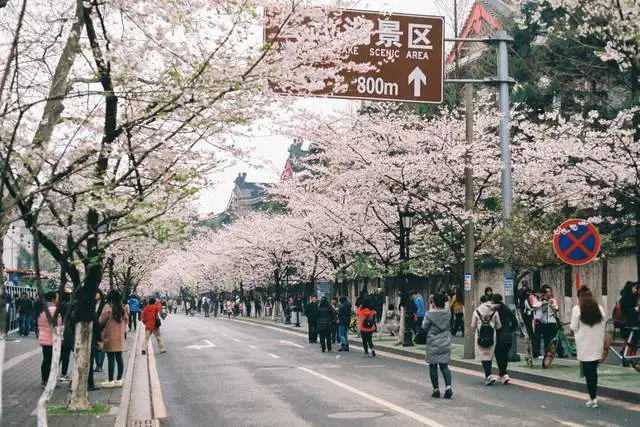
570 286 605 408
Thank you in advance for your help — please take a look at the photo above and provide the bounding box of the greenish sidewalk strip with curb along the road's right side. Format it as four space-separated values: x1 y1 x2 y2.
230 317 640 403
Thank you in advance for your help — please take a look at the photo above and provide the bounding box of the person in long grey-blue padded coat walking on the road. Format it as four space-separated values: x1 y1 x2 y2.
421 293 453 399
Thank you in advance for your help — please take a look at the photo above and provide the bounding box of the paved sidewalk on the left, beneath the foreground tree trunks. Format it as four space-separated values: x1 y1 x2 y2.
2 324 144 427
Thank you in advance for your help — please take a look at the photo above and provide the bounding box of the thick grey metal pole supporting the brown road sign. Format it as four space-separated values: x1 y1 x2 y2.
495 31 518 361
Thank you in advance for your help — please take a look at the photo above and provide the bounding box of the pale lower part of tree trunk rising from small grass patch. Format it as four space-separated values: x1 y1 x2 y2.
67 322 93 411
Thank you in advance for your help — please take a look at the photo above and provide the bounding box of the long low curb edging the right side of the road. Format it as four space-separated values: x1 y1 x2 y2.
232 319 640 403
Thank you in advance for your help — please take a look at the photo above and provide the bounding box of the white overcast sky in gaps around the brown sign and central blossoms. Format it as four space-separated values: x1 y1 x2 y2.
198 0 452 215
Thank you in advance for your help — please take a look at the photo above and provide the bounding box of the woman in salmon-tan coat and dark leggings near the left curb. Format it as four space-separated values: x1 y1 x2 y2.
98 290 129 387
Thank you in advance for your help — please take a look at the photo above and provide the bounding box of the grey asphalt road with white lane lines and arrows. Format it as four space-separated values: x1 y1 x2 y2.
157 315 640 427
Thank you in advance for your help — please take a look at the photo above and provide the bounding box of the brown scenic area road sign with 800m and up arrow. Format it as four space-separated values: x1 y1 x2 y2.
265 10 444 103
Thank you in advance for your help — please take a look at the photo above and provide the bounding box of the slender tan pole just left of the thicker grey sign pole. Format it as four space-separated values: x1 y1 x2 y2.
464 83 475 359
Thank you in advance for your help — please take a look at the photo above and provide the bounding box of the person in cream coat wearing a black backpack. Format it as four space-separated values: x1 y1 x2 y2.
471 295 502 386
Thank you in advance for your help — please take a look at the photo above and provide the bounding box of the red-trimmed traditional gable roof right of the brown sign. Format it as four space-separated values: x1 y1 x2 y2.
447 0 518 65
